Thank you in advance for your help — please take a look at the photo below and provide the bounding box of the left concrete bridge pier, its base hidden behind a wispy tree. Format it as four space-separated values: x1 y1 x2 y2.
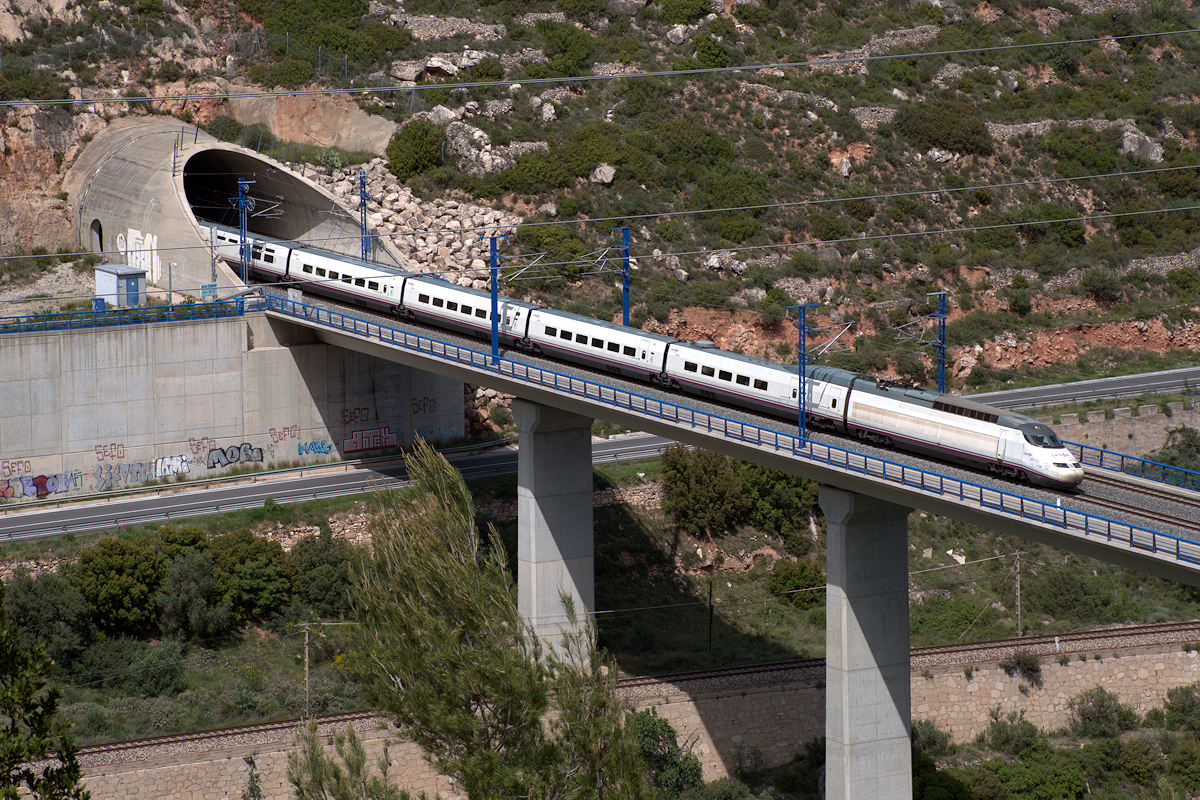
512 399 595 645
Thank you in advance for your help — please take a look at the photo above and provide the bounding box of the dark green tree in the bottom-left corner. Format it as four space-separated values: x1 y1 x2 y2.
0 585 90 800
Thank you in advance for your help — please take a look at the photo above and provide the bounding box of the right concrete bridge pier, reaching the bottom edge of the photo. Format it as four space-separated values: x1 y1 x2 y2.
820 486 912 800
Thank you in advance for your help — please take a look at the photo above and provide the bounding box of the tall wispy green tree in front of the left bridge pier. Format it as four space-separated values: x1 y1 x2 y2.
352 444 644 800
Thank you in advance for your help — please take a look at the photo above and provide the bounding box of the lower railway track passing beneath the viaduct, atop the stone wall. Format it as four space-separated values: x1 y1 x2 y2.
79 620 1200 766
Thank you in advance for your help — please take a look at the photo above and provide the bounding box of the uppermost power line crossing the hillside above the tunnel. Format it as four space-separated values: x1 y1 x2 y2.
9 28 1200 108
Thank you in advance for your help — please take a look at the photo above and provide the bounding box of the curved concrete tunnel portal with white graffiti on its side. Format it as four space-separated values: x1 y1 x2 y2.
64 118 402 297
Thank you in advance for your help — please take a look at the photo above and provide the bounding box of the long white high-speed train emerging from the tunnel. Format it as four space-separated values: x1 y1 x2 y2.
209 225 1084 488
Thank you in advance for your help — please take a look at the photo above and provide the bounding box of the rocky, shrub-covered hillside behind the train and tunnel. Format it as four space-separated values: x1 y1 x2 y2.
0 0 1200 387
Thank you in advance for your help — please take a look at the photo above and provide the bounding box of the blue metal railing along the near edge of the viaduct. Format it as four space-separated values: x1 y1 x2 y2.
264 296 1200 565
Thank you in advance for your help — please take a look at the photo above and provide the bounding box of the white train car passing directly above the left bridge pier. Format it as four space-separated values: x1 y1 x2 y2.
528 308 678 384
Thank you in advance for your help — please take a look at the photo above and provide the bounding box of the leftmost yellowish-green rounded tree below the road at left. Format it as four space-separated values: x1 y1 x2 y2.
71 537 163 636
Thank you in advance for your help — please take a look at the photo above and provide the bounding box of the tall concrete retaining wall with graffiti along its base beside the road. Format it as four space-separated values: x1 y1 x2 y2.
0 314 463 500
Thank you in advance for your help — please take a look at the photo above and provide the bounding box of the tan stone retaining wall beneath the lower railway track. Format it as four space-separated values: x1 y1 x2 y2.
84 645 1200 800
